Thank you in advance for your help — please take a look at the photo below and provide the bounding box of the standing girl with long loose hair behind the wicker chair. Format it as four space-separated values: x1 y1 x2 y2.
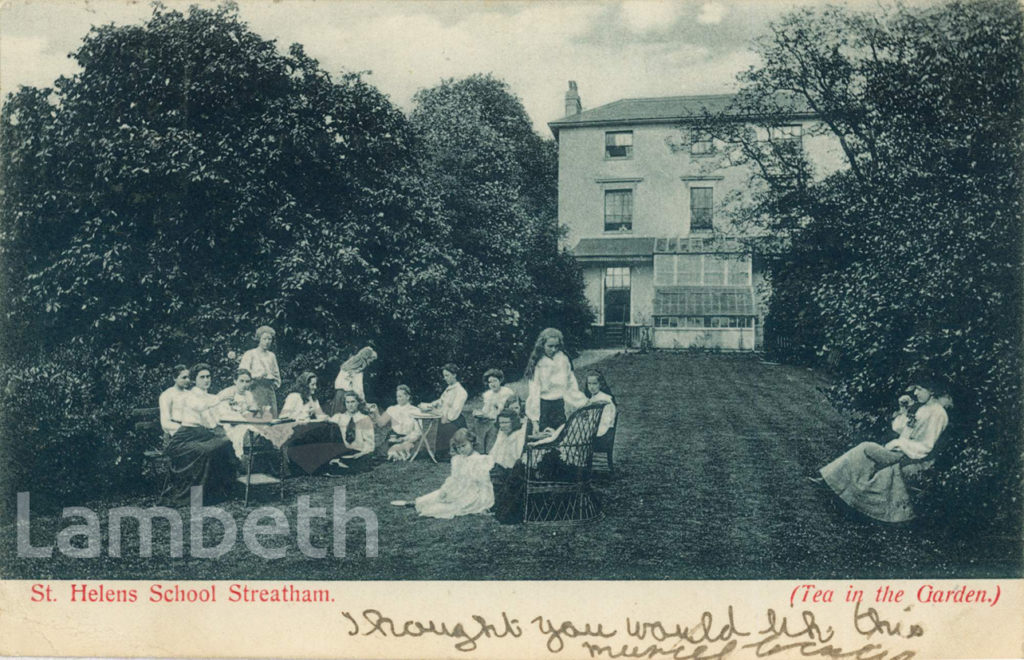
524 327 587 429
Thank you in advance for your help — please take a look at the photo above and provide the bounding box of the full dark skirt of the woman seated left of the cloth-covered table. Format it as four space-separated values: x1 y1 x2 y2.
163 427 239 501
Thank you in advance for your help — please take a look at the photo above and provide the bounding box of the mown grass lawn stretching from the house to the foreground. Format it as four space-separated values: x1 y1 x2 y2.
0 353 1020 579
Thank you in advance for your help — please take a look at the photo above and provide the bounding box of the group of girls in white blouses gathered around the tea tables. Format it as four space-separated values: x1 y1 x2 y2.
153 326 615 518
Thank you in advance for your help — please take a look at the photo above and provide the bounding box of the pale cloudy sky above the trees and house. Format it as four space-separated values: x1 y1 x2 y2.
0 0 839 136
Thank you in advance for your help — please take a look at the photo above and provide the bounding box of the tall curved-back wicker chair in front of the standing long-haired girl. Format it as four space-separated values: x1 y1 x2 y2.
523 403 605 522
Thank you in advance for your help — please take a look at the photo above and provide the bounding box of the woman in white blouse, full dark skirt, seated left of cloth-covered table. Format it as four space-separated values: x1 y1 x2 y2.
164 363 239 501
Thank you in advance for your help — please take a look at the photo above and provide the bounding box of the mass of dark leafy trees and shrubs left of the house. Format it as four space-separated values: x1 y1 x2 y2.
0 5 589 515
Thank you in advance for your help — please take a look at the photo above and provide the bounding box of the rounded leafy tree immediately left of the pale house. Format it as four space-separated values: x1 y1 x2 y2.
411 75 591 380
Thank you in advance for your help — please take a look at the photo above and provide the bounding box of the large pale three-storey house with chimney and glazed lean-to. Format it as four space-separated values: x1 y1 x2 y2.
549 82 839 351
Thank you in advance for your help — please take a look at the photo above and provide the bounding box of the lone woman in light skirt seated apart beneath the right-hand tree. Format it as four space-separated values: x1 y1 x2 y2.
812 379 949 523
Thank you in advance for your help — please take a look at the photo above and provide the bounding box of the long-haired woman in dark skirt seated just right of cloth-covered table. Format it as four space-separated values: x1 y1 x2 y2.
281 371 345 474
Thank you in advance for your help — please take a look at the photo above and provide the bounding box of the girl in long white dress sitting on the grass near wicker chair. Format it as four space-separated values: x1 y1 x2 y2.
414 429 495 519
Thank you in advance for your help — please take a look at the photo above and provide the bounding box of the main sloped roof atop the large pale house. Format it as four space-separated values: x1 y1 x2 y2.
548 94 810 135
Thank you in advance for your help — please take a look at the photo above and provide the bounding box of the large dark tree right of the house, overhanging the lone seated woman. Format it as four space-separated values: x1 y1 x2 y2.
706 0 1024 532
